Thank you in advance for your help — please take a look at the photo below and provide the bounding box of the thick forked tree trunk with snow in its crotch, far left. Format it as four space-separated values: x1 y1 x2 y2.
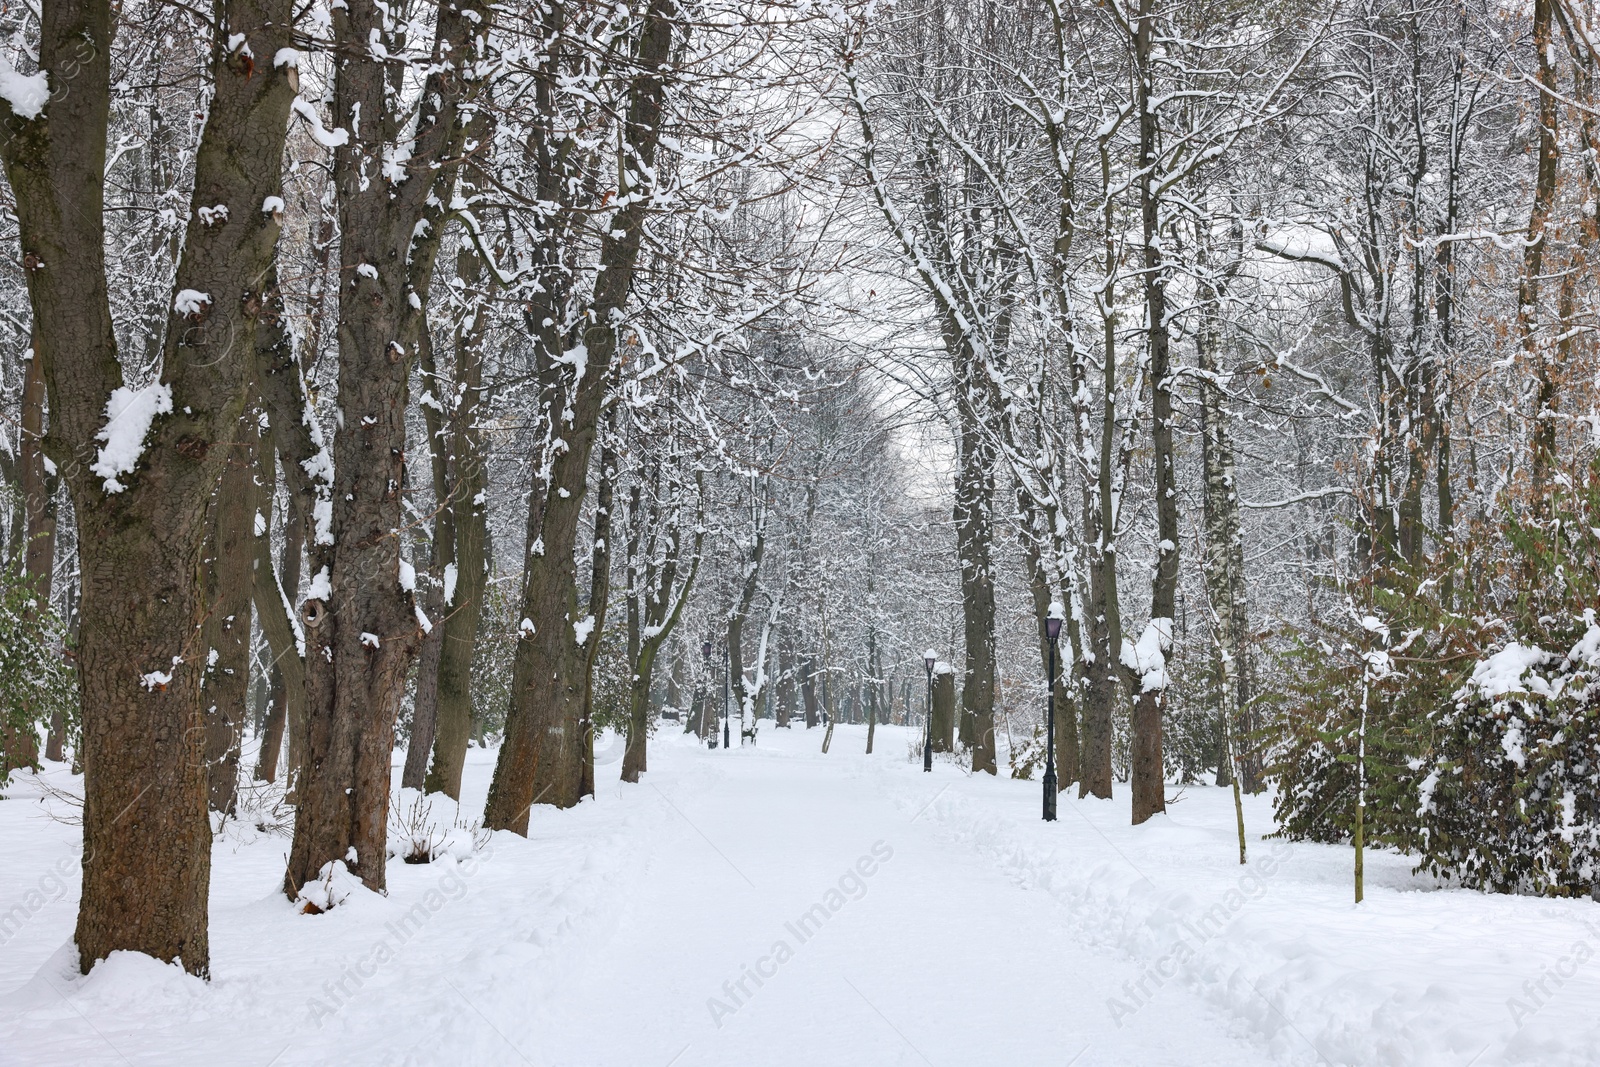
0 0 291 974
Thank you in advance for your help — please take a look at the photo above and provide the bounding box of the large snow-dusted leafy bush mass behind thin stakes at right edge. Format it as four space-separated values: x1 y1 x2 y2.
1264 459 1600 894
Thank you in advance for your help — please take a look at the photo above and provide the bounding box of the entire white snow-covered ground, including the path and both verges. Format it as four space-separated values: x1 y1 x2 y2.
0 726 1600 1067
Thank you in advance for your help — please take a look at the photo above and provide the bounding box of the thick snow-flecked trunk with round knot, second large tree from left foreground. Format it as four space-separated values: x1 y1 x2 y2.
283 0 491 899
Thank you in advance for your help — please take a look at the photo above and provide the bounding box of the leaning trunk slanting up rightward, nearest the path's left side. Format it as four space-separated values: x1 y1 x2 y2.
483 0 677 833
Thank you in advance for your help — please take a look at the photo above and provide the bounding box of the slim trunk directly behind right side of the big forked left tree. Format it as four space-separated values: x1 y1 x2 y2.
202 413 261 814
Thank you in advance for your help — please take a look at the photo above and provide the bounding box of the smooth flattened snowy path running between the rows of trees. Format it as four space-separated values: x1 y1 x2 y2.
542 731 1262 1067
